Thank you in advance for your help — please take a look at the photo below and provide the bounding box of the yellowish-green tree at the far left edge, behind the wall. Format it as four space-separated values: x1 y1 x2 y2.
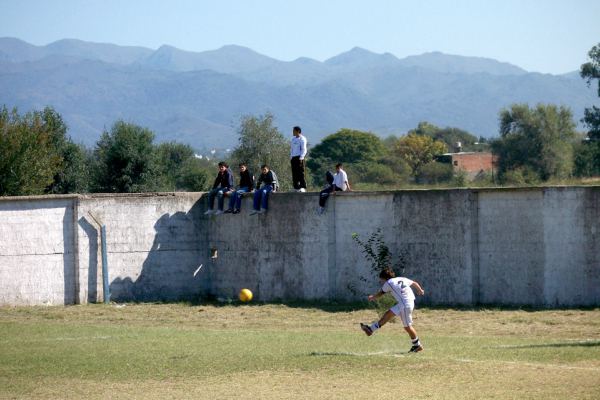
0 106 62 196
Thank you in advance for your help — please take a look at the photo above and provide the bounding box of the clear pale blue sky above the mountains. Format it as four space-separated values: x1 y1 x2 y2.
0 0 600 74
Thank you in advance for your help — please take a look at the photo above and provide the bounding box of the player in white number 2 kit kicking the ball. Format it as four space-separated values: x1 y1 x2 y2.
360 269 425 353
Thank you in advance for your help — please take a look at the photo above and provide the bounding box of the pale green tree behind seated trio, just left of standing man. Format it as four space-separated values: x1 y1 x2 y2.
231 113 292 190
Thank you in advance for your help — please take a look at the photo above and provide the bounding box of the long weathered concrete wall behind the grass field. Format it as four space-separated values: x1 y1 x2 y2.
0 187 600 306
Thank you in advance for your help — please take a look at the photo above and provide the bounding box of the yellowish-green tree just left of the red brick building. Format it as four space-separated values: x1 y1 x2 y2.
393 133 448 176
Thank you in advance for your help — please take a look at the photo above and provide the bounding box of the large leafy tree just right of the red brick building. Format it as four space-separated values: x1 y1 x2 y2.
492 104 576 180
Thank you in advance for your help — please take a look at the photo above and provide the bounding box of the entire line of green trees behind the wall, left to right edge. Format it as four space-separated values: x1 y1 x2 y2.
0 44 600 196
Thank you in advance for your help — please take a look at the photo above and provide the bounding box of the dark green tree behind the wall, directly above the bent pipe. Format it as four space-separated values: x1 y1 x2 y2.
94 121 164 193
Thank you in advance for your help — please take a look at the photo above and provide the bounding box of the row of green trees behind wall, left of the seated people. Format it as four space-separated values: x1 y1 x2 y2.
0 106 210 196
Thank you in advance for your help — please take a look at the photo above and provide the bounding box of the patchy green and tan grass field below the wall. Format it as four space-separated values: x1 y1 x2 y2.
0 304 600 400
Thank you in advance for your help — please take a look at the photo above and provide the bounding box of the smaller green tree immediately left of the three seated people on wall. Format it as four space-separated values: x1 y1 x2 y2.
156 142 207 192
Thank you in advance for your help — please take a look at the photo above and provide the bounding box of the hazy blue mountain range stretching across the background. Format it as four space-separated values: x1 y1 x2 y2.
0 38 598 149
